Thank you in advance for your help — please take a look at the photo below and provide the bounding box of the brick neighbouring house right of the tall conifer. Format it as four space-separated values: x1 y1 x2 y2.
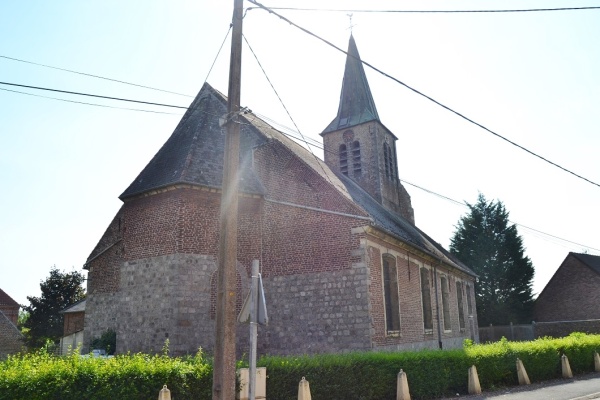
534 253 600 336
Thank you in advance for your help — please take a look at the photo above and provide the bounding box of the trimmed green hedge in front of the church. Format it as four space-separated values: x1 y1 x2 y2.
0 333 600 400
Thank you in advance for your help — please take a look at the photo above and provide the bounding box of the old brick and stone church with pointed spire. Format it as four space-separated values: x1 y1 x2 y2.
84 36 478 355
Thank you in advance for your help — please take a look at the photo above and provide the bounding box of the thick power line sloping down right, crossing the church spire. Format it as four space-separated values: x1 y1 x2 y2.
248 0 600 187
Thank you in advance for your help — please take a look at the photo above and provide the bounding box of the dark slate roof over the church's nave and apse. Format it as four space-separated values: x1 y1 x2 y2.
116 81 475 276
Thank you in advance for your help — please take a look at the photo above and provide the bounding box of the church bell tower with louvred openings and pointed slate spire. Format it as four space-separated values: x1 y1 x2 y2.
321 34 415 224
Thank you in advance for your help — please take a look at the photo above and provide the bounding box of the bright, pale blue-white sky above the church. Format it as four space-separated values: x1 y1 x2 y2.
0 0 600 310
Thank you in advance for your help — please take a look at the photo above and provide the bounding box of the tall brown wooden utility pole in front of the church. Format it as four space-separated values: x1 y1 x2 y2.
212 0 243 400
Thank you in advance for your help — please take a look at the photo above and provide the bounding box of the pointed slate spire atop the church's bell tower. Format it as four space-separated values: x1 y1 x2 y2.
323 34 379 133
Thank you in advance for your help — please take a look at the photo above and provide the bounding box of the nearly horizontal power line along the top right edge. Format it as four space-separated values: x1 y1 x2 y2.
247 2 600 14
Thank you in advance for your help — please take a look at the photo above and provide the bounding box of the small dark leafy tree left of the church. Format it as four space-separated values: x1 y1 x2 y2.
23 267 85 348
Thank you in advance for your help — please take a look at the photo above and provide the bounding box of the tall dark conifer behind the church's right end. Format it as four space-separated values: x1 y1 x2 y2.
450 194 534 325
